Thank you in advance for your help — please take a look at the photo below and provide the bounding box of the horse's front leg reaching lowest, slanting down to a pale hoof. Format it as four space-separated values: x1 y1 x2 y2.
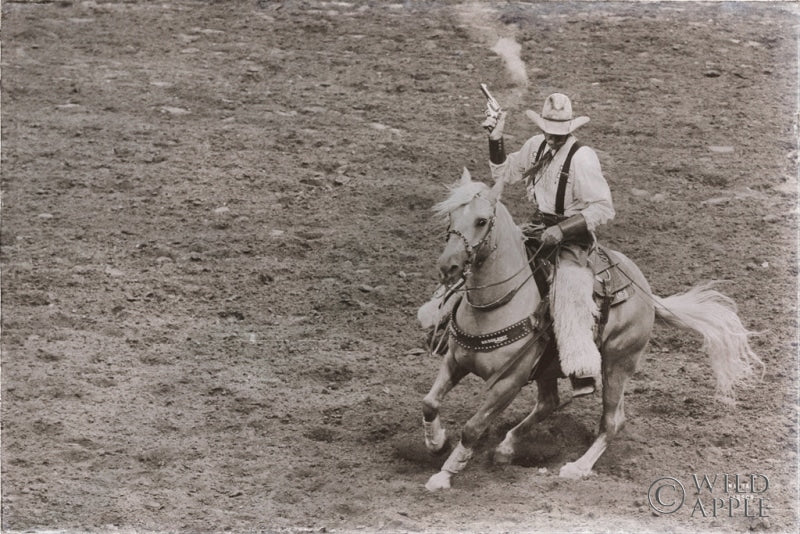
425 365 530 491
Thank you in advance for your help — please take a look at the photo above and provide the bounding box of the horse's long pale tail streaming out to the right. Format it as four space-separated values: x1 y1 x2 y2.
653 282 764 401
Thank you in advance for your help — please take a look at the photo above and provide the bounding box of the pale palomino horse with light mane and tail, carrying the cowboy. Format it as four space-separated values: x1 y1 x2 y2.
420 168 763 491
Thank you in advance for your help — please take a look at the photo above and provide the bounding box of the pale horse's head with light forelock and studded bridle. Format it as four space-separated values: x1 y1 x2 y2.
434 169 503 285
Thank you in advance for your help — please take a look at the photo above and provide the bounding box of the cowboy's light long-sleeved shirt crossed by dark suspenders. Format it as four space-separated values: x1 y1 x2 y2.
489 135 614 232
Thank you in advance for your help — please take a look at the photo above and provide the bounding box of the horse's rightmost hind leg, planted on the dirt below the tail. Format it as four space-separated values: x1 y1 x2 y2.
558 351 642 478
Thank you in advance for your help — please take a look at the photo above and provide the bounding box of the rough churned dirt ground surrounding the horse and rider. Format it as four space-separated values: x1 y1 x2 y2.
0 0 798 532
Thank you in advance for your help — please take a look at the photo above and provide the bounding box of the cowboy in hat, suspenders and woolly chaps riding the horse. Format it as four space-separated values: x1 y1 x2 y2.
484 93 614 396
